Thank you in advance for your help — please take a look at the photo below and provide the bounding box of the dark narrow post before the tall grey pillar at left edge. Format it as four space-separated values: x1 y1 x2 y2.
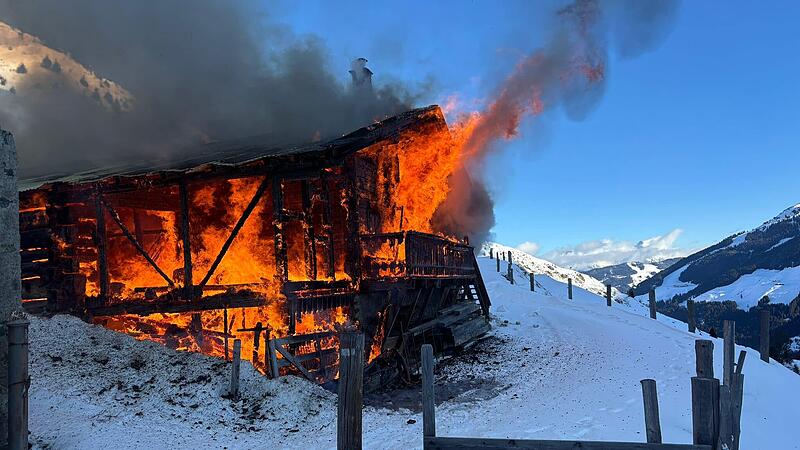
6 320 30 450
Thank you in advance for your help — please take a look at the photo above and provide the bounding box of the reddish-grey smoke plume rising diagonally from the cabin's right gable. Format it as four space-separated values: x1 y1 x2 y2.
437 0 679 244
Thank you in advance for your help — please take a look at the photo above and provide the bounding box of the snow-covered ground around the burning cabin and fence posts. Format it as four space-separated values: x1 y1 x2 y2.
30 258 800 449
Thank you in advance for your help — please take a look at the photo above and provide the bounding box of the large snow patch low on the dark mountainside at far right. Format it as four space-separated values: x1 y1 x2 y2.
695 267 800 309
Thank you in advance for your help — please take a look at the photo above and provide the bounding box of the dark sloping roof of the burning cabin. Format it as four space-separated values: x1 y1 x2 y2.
19 105 445 191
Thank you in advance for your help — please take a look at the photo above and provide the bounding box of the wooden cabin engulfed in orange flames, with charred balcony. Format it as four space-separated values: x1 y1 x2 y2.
20 106 490 381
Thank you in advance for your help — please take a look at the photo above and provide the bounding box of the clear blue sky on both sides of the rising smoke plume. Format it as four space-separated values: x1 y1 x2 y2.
267 1 800 268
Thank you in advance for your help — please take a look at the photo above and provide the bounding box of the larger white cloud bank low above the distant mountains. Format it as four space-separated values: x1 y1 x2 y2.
543 228 690 269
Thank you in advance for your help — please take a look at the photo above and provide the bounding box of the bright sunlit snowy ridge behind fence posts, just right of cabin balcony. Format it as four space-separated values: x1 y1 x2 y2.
481 242 621 297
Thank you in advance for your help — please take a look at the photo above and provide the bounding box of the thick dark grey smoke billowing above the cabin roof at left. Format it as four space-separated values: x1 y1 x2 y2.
0 0 412 176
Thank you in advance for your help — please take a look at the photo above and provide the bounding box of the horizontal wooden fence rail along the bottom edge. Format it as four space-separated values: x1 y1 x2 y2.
423 437 712 450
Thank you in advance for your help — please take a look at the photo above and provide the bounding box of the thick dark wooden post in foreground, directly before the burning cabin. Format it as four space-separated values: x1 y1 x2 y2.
336 332 364 450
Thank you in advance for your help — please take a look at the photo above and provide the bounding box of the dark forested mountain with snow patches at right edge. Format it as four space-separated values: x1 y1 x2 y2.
636 204 800 309
